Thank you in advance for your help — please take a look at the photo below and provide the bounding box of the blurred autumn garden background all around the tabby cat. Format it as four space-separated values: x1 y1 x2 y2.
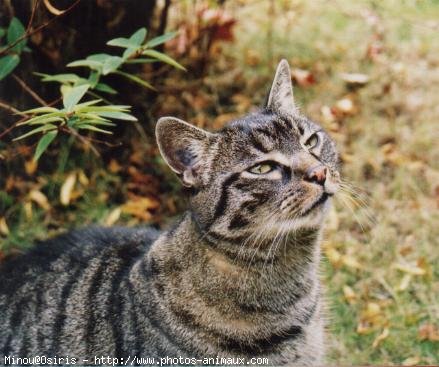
0 0 439 366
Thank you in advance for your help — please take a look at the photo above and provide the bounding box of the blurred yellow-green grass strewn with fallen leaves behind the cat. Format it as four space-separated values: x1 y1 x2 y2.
0 0 439 365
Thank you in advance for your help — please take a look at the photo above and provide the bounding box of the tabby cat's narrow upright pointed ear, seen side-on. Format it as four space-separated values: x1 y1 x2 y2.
265 59 296 114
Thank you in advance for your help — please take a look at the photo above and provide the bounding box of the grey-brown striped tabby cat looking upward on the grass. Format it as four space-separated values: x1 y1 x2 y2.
0 60 340 366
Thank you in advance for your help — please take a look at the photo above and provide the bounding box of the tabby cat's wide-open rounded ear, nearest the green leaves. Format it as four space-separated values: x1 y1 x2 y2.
155 117 214 187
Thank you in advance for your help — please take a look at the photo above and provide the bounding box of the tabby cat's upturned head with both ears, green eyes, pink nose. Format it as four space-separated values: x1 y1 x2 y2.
156 60 339 240
